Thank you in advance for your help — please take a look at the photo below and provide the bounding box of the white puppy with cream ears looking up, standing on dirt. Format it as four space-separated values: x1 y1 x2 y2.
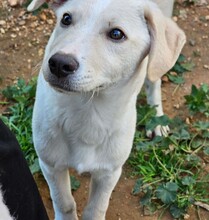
28 0 185 220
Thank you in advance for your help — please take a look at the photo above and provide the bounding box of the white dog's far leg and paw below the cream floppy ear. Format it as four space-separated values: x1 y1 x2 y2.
145 79 169 137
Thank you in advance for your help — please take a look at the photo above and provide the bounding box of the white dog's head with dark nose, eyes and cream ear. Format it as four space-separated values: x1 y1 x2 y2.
28 0 185 92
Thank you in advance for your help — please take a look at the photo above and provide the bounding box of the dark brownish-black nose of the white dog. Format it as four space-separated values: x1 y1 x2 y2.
49 53 79 77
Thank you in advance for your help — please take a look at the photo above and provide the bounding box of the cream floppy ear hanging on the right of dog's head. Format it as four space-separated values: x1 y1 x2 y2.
144 3 186 81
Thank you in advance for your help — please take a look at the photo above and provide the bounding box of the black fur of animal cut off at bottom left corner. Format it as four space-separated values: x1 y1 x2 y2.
0 120 49 220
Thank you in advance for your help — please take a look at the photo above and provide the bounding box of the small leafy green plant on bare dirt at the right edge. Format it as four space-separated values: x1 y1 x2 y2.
185 84 209 117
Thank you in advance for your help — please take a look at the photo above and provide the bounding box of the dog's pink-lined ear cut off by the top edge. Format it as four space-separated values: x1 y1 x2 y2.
27 0 67 11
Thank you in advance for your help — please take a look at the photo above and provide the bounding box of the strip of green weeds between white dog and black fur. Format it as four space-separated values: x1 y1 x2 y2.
1 78 39 171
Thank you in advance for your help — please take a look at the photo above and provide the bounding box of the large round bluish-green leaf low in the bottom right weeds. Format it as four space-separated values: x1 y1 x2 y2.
156 182 178 204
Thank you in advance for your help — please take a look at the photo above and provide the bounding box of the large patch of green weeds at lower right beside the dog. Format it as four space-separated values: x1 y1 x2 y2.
129 102 209 219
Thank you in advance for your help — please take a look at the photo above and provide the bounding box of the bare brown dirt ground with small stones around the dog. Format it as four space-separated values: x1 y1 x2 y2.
0 0 209 220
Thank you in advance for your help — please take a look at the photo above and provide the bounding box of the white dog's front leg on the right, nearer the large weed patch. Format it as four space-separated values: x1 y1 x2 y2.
82 168 121 220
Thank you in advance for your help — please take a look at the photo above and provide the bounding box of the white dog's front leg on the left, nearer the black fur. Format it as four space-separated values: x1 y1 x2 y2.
39 159 78 220
